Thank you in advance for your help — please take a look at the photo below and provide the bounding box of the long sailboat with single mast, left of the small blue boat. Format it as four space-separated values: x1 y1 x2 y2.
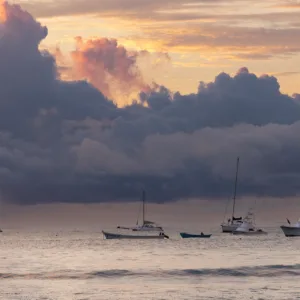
102 190 169 240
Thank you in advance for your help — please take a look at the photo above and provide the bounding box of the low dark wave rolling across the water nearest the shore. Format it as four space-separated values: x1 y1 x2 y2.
0 264 300 280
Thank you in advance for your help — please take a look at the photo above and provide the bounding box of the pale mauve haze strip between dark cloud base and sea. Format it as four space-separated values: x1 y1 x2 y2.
0 198 300 230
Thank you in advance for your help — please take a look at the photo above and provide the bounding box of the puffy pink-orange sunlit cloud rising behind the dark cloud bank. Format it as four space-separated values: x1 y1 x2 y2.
52 36 171 106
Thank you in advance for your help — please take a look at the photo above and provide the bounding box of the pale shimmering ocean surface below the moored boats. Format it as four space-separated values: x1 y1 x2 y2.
0 228 300 300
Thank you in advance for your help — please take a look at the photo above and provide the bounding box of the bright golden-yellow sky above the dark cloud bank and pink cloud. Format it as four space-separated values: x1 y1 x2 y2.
15 0 300 94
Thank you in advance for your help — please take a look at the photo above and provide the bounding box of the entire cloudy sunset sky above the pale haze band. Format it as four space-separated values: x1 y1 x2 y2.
0 0 300 204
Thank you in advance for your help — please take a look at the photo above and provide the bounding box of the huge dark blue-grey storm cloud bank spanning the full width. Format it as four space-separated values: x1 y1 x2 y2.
0 3 300 204
